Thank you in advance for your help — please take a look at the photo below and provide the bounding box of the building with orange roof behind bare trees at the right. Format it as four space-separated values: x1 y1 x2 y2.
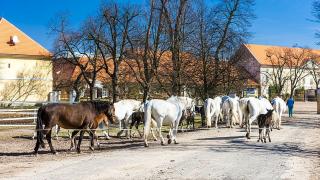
238 44 320 100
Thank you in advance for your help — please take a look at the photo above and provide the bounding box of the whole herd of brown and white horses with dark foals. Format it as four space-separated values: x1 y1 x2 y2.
34 96 286 154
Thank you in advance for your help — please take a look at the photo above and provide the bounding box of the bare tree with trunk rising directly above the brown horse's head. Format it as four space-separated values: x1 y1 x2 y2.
90 2 138 102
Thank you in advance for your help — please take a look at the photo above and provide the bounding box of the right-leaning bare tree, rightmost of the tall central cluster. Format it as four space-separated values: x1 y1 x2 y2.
210 0 254 93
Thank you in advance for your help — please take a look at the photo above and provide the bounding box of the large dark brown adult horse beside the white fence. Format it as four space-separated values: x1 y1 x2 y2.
34 101 115 154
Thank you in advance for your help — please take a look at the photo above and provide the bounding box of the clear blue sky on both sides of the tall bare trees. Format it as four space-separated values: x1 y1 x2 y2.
0 0 320 50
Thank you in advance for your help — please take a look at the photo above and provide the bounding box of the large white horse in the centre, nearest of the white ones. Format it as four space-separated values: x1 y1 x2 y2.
144 96 185 147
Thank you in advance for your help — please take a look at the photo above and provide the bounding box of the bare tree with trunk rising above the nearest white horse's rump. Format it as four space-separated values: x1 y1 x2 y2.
126 0 168 102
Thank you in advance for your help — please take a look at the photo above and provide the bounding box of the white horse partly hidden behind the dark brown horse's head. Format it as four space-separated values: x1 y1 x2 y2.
110 99 143 138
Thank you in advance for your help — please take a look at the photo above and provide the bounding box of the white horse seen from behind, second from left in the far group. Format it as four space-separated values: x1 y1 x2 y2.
222 97 242 128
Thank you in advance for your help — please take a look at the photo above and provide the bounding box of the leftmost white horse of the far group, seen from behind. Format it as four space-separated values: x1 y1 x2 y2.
204 96 222 128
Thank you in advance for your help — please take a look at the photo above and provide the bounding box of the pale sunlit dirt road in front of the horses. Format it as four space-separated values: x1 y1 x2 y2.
0 102 320 180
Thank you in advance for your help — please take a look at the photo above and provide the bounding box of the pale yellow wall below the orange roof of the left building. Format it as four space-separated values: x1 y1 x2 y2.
0 57 52 101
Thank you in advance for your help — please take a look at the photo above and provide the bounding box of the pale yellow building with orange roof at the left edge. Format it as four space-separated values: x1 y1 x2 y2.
0 18 52 102
